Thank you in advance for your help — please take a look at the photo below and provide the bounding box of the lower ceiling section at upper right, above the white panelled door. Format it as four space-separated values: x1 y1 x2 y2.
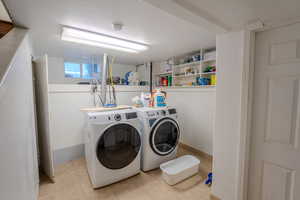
180 0 300 29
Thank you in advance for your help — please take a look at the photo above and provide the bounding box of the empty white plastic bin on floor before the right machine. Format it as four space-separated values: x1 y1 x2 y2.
160 155 200 185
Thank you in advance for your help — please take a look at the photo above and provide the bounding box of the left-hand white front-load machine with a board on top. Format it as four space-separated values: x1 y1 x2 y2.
85 109 142 188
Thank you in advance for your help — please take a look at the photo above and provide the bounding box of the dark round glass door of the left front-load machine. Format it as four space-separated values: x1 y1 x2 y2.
96 124 141 169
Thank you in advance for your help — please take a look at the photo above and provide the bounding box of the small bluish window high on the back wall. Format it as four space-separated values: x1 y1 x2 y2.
64 62 100 79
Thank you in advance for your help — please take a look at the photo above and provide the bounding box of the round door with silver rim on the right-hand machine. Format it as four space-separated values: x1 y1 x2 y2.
150 118 180 156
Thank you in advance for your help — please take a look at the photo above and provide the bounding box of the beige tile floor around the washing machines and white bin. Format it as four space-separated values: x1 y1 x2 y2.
39 148 212 200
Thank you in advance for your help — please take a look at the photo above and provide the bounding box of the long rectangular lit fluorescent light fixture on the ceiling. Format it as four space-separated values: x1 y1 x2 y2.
61 26 148 53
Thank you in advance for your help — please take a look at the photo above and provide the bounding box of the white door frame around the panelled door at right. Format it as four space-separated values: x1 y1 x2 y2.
235 21 299 200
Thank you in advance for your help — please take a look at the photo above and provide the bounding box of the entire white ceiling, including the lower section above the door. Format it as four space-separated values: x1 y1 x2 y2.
4 0 300 64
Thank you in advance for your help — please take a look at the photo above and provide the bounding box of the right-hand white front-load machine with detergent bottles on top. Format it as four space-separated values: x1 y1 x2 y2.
137 107 180 171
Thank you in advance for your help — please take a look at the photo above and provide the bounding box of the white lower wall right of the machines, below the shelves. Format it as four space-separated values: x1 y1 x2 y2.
165 88 216 155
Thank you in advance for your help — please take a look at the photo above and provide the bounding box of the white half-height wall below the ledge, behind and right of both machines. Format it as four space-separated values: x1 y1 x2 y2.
49 84 215 155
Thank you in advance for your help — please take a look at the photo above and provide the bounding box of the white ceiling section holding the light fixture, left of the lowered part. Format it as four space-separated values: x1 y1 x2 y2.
4 0 215 64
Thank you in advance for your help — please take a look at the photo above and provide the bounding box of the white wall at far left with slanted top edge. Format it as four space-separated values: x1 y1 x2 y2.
0 29 38 200
